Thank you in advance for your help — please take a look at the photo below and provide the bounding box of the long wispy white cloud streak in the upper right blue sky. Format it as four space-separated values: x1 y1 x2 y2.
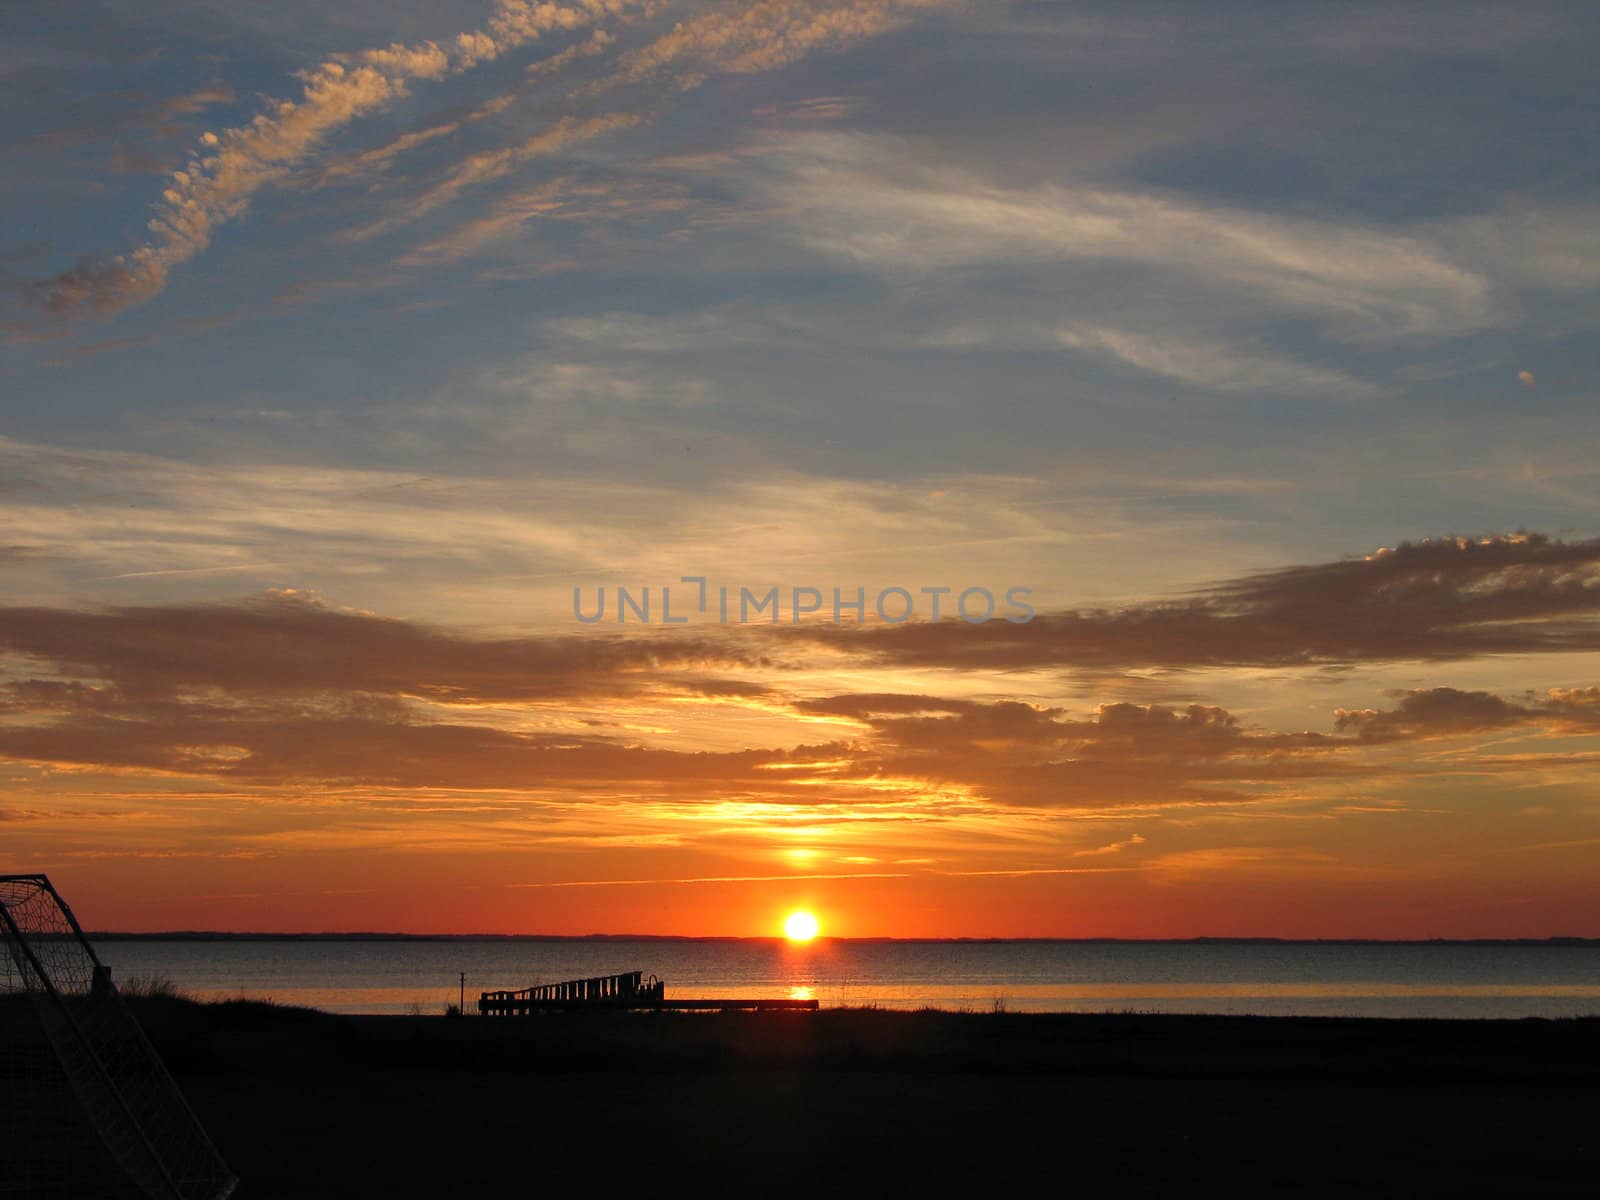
750 133 1493 339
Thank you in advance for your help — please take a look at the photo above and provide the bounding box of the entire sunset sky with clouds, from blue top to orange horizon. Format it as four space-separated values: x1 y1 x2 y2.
0 0 1600 938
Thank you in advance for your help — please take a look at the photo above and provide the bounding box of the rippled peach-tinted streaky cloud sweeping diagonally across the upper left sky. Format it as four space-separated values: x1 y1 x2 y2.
27 0 949 318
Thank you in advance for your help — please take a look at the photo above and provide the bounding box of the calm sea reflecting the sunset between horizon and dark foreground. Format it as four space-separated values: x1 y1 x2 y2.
98 941 1600 1018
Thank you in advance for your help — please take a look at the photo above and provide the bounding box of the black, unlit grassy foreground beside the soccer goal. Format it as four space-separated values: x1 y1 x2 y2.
116 1000 1600 1200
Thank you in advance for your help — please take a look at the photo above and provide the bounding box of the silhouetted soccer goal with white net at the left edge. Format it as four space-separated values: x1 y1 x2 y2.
0 875 238 1200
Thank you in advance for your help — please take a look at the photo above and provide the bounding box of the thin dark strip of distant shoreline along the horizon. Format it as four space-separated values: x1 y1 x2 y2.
85 930 1600 947
